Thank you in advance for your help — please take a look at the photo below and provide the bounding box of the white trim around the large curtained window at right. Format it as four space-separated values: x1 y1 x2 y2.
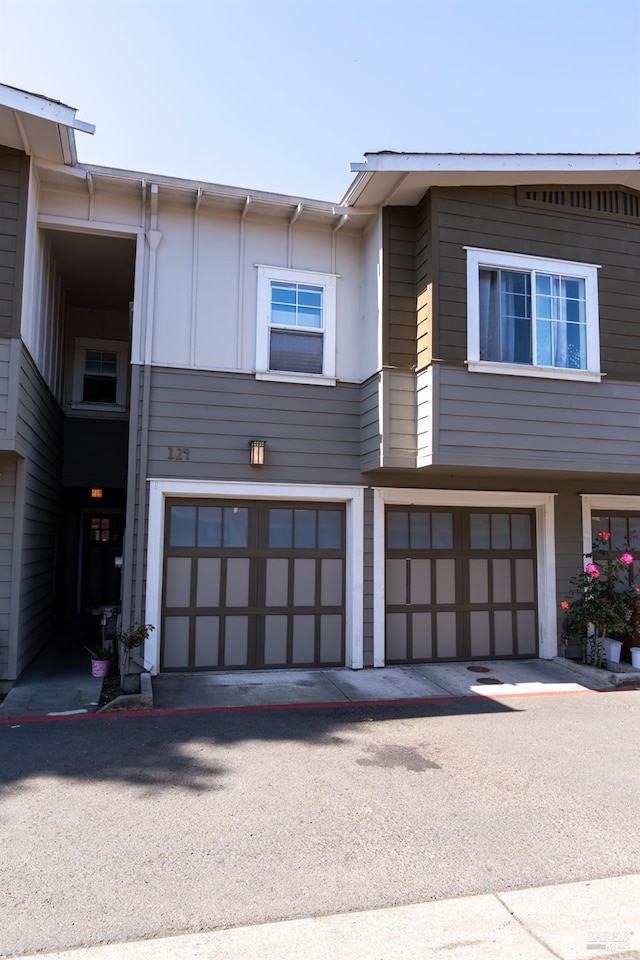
463 247 602 383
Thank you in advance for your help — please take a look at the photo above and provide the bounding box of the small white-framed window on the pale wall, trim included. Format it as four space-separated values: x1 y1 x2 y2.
256 265 337 384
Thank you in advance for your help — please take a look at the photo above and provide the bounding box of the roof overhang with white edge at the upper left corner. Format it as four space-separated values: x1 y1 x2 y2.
0 84 95 166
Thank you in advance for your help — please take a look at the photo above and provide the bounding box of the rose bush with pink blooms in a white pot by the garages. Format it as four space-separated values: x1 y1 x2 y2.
561 530 640 667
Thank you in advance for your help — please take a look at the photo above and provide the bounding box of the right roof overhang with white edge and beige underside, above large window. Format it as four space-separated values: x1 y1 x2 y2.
341 152 640 208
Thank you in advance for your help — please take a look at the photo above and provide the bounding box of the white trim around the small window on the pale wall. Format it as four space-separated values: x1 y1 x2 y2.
255 263 338 386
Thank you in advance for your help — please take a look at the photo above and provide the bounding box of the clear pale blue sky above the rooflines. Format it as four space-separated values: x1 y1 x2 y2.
0 0 640 201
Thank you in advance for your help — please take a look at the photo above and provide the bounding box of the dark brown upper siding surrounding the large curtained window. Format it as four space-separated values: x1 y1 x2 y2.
432 185 640 376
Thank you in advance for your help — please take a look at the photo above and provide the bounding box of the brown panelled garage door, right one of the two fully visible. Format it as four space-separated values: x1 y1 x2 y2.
385 507 538 663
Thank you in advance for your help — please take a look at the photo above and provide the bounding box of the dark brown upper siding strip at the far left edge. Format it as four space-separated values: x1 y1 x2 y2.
0 148 29 336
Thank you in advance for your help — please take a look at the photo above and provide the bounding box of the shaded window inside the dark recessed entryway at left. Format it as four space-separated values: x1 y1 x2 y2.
71 337 128 413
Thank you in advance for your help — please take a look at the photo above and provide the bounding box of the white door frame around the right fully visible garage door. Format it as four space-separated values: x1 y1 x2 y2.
373 487 558 667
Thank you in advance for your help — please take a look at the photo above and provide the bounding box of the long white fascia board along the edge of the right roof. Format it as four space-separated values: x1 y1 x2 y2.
349 153 640 175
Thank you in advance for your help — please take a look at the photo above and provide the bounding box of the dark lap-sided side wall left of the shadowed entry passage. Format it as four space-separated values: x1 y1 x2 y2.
16 348 63 676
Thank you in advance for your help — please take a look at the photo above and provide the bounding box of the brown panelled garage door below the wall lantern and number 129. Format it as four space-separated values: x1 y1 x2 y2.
160 500 345 671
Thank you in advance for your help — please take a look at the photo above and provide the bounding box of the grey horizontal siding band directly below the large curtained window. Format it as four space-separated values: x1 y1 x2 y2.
418 364 640 474
